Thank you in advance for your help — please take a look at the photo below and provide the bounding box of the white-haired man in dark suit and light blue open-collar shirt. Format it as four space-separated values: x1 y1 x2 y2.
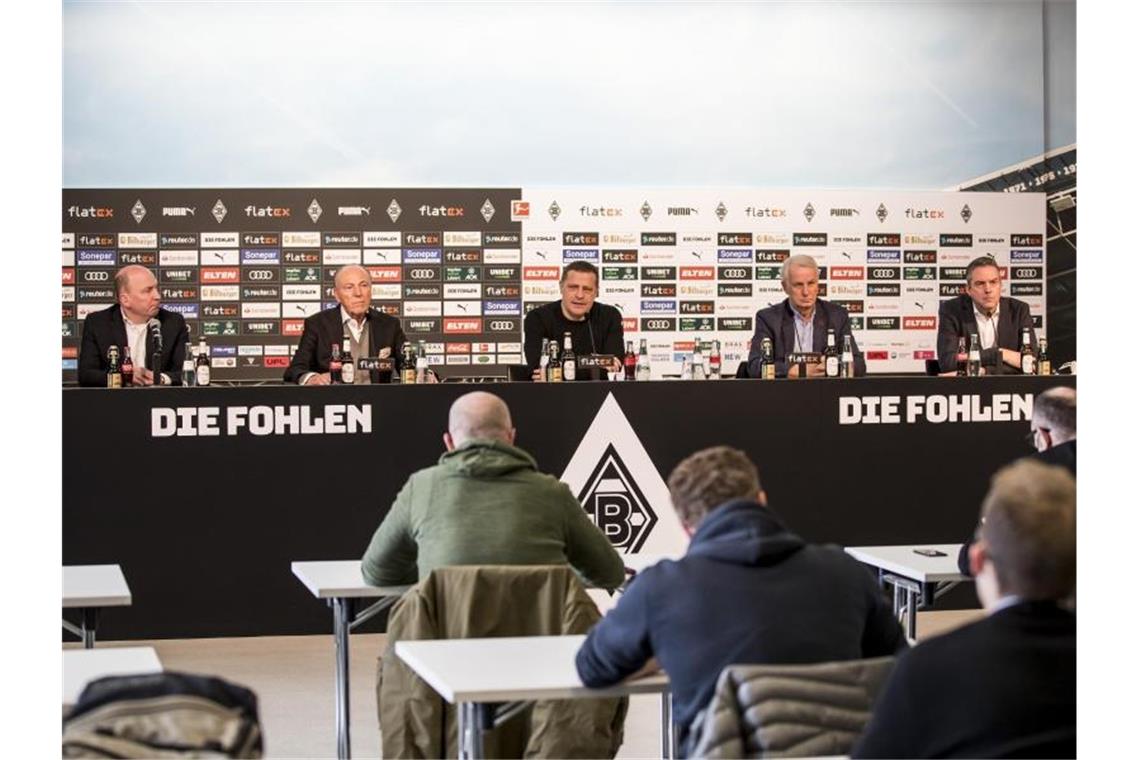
748 254 866 377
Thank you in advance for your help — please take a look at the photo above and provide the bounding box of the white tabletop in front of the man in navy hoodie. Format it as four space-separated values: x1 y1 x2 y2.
396 636 669 704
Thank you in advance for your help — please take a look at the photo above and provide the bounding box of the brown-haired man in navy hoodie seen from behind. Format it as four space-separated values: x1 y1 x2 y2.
577 447 906 747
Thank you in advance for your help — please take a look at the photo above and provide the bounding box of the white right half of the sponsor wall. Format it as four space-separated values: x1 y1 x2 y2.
512 187 1045 376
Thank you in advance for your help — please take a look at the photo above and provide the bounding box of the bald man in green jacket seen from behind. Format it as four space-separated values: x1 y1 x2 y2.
360 391 625 589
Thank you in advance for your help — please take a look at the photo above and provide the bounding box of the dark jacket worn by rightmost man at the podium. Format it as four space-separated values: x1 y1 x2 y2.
938 295 1037 375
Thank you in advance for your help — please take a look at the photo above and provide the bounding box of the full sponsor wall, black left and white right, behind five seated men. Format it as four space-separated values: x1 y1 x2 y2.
62 188 1045 382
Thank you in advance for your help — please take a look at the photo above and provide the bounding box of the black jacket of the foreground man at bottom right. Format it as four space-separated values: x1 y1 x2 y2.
852 602 1076 758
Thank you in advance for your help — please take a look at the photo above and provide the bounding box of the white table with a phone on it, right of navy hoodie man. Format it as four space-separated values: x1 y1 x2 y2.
845 544 971 644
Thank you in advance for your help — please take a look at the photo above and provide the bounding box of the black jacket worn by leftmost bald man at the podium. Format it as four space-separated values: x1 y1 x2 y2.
79 303 190 386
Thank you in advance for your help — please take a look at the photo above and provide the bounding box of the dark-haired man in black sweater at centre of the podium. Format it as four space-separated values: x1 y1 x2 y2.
522 261 625 379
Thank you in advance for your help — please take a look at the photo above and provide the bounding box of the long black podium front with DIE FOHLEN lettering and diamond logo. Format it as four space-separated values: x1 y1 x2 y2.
63 376 1075 639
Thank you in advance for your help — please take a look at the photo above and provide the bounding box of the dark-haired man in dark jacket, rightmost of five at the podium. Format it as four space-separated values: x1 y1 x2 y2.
938 256 1037 375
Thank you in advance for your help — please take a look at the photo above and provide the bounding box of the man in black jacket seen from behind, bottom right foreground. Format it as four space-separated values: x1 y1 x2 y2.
852 459 1076 758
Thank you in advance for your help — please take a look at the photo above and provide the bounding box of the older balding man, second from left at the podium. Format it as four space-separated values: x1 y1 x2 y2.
285 264 406 385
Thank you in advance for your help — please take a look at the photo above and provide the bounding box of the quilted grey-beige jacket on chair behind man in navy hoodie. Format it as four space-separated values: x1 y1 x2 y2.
690 657 895 758
